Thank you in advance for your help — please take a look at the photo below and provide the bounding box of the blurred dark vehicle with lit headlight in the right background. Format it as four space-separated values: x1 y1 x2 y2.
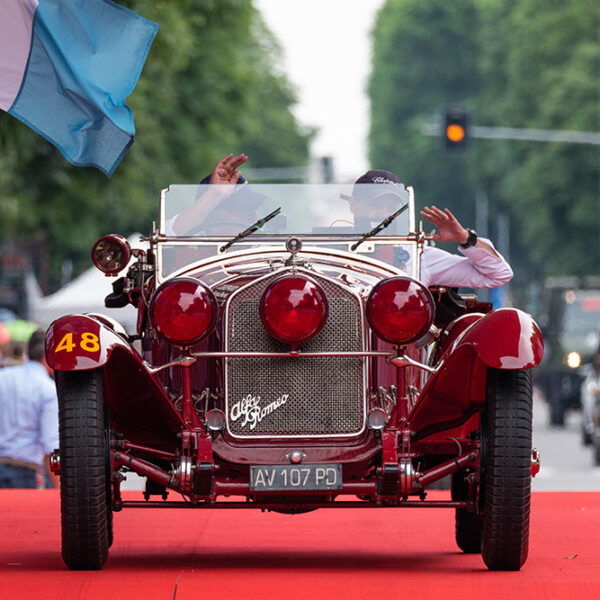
536 277 600 426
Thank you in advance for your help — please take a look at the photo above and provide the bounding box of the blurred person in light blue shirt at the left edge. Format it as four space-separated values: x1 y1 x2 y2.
0 330 59 488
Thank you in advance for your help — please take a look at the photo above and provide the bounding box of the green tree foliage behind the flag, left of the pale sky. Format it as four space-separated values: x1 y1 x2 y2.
0 0 311 290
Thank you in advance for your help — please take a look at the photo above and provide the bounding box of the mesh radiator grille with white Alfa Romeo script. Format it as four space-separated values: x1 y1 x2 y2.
226 275 365 437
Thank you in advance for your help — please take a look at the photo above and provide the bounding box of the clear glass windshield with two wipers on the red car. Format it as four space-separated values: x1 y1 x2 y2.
157 183 417 280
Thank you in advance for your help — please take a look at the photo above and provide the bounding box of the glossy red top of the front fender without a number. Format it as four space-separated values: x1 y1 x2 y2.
450 308 544 369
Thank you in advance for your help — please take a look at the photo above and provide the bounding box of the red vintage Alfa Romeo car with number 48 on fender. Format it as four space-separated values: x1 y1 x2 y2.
46 184 543 570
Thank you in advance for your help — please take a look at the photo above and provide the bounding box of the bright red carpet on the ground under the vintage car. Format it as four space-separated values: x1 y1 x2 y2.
0 490 600 600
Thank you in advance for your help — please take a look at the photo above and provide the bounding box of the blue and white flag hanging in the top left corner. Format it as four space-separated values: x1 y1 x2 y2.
0 0 158 175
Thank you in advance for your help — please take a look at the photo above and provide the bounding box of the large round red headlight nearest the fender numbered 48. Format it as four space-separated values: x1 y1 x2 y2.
150 277 218 346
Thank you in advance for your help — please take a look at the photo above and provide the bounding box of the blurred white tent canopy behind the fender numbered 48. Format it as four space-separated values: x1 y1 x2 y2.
27 233 148 333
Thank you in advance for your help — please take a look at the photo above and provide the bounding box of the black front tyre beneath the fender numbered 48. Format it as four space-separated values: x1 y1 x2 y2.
56 369 112 569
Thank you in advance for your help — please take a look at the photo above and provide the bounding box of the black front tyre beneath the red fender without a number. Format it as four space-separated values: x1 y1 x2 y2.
481 369 532 571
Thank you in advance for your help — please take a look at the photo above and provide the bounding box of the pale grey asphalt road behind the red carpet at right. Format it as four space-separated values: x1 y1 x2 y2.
122 396 600 491
